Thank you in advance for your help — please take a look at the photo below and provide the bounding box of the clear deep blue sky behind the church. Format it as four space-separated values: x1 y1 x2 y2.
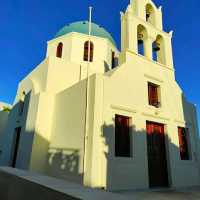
0 0 200 128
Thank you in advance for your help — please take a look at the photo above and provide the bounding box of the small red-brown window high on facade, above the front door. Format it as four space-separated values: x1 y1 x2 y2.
148 83 160 108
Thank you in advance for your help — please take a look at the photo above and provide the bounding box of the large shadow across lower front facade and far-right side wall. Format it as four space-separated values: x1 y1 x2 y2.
102 91 200 190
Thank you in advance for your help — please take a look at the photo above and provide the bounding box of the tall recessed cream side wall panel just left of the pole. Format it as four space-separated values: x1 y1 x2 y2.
47 81 86 183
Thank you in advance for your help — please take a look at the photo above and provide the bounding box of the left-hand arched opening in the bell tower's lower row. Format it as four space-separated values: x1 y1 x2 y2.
137 25 147 56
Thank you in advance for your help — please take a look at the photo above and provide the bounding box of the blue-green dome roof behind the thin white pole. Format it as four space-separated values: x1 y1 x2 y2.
55 21 116 46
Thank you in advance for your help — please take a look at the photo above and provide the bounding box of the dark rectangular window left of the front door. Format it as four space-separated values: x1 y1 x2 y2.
115 115 131 157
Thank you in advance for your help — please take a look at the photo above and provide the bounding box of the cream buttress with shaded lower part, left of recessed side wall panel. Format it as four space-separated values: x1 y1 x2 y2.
29 93 54 173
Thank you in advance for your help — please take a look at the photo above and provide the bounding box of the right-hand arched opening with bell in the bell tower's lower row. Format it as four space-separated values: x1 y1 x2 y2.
152 35 165 64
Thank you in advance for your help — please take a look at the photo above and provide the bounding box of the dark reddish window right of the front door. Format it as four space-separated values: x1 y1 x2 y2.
178 127 190 160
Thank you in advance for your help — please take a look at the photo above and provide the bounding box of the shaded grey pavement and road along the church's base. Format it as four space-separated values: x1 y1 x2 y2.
0 167 200 200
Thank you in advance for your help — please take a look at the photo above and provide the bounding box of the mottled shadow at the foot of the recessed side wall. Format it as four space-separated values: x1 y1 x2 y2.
47 147 83 183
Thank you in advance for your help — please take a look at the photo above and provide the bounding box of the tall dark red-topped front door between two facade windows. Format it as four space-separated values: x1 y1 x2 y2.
146 122 168 188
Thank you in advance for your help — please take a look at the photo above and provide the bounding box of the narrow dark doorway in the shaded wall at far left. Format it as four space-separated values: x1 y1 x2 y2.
11 127 21 168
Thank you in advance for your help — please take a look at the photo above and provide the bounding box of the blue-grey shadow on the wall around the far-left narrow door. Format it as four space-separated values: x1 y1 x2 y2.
0 91 34 169
